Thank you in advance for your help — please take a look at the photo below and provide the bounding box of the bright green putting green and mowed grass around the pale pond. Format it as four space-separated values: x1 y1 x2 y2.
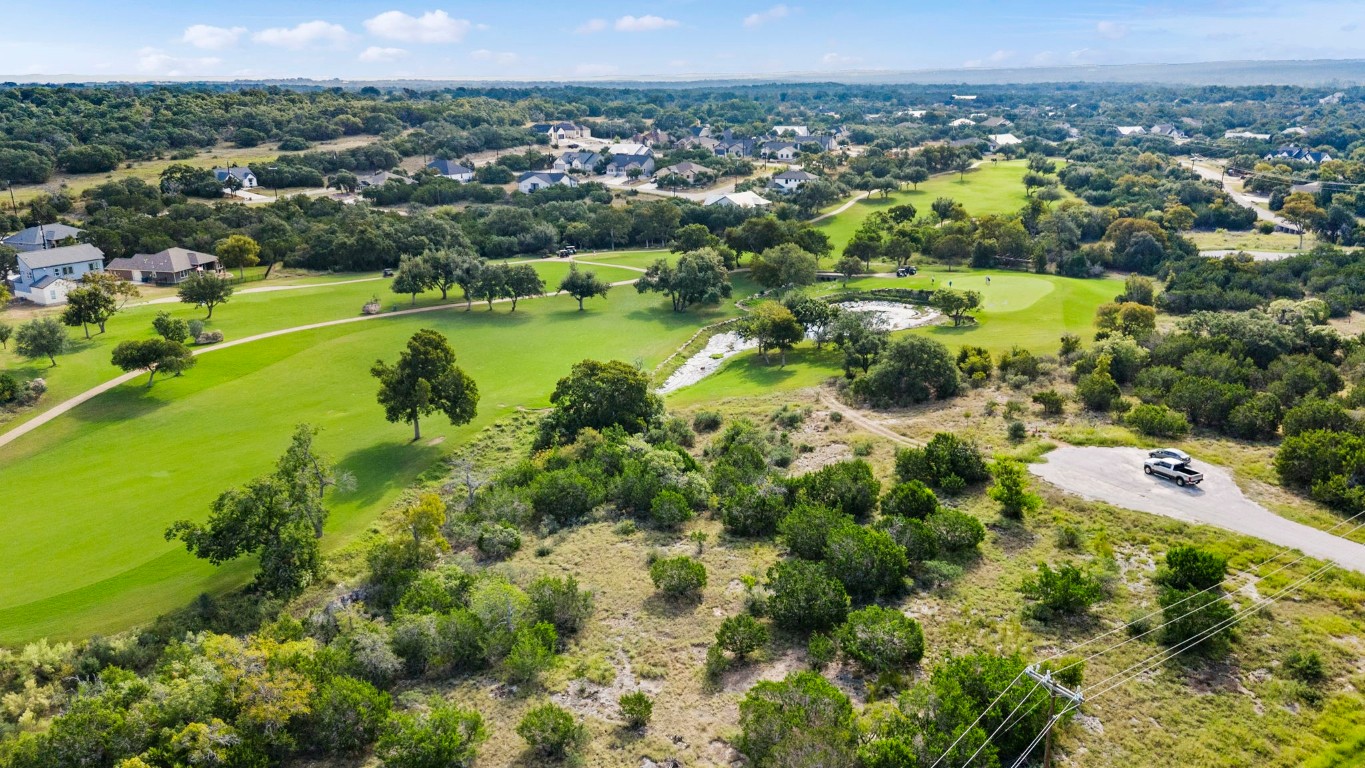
669 266 1123 405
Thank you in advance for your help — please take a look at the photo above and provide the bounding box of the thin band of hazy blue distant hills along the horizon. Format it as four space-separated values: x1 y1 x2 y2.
0 59 1365 86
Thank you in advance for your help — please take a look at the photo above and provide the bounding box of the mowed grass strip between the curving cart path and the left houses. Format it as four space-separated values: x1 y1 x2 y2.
0 259 639 430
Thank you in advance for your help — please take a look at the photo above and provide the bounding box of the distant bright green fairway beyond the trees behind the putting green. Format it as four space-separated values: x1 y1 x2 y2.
816 160 1028 252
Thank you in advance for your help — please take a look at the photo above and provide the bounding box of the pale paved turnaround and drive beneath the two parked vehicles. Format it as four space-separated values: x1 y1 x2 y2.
1029 446 1365 573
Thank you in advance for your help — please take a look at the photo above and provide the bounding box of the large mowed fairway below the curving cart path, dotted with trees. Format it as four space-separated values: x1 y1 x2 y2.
0 280 752 644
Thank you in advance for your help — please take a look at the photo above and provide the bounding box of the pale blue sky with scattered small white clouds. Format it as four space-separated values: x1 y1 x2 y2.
8 0 1365 79
